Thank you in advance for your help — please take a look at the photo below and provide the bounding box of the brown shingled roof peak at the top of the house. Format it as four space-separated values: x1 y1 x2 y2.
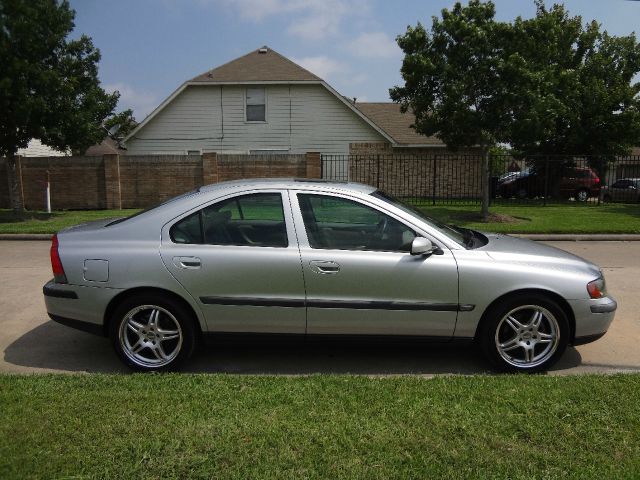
191 46 322 83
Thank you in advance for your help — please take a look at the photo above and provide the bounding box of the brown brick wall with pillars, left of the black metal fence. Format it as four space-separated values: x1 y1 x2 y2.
0 153 321 210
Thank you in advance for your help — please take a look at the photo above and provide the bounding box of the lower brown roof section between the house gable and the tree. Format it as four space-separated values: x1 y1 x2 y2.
355 102 443 146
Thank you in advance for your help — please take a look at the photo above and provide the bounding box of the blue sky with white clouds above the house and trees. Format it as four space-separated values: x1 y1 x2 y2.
71 0 640 121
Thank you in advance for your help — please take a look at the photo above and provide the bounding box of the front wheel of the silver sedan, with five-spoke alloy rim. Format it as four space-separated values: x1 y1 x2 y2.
477 294 569 373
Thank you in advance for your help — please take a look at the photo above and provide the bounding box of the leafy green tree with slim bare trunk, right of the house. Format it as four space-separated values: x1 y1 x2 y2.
389 0 510 219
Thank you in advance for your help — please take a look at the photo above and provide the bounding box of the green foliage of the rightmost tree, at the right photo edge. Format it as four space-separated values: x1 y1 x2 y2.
505 0 640 156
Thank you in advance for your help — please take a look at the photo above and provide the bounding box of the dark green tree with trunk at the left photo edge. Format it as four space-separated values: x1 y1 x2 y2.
0 0 119 214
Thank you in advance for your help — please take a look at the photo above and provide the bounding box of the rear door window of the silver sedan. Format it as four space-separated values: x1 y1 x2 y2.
170 193 288 247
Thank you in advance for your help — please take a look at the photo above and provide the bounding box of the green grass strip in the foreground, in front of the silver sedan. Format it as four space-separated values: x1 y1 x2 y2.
0 374 640 479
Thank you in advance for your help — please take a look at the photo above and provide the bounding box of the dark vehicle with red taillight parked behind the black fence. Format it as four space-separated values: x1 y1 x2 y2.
497 167 600 202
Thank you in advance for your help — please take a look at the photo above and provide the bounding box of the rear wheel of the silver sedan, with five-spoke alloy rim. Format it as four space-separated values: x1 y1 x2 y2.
109 294 196 372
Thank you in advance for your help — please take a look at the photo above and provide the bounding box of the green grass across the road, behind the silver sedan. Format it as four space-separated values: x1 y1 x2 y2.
0 204 640 233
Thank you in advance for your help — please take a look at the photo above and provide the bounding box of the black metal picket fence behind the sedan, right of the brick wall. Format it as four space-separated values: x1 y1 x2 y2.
322 153 640 205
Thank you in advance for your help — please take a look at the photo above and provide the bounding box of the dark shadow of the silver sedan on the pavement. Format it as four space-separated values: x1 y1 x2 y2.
4 321 582 375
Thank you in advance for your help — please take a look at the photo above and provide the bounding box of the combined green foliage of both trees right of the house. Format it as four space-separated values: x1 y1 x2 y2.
390 0 640 155
